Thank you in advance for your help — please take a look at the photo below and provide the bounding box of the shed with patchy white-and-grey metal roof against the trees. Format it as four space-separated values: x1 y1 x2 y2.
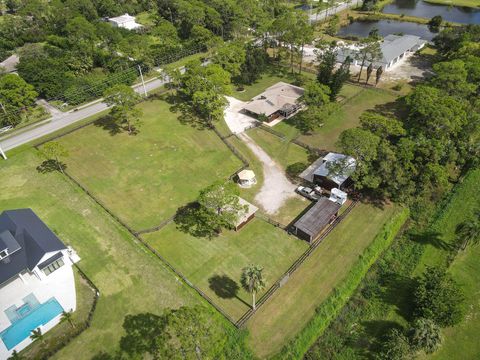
313 153 357 190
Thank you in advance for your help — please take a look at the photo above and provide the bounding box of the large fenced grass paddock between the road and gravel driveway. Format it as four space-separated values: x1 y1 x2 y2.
49 96 241 230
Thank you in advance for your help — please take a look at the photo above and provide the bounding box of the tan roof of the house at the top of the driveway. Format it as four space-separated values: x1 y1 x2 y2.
244 81 304 116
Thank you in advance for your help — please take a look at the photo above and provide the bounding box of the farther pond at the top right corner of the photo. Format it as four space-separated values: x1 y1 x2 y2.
382 0 480 24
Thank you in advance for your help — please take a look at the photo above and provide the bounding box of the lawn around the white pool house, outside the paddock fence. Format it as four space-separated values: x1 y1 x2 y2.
0 149 198 360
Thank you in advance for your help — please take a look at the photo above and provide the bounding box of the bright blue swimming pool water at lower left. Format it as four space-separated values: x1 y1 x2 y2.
0 298 63 350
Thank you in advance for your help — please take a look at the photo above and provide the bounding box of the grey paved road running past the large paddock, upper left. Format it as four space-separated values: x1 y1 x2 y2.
0 79 166 151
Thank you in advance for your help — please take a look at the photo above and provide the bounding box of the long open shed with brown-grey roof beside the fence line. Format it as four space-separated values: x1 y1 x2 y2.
291 197 341 244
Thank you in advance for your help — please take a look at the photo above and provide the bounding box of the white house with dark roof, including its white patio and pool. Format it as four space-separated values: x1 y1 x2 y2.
0 209 80 359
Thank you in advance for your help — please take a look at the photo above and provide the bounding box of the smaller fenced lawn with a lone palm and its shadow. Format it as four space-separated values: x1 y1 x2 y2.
142 219 308 320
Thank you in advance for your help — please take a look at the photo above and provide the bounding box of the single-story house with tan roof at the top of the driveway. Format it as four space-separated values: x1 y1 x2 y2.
243 81 304 122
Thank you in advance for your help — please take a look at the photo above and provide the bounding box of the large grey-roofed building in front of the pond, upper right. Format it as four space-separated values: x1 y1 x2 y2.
337 35 427 71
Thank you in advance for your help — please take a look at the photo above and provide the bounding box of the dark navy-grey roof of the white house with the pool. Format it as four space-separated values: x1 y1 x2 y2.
0 209 66 284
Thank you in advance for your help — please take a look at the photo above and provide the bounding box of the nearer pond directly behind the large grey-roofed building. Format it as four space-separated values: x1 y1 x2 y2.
338 20 437 41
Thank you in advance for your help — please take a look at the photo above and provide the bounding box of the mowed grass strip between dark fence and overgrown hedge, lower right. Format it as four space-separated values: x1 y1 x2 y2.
247 203 397 358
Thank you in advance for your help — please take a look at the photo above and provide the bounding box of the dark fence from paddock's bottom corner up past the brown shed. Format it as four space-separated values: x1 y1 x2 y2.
235 201 358 328
